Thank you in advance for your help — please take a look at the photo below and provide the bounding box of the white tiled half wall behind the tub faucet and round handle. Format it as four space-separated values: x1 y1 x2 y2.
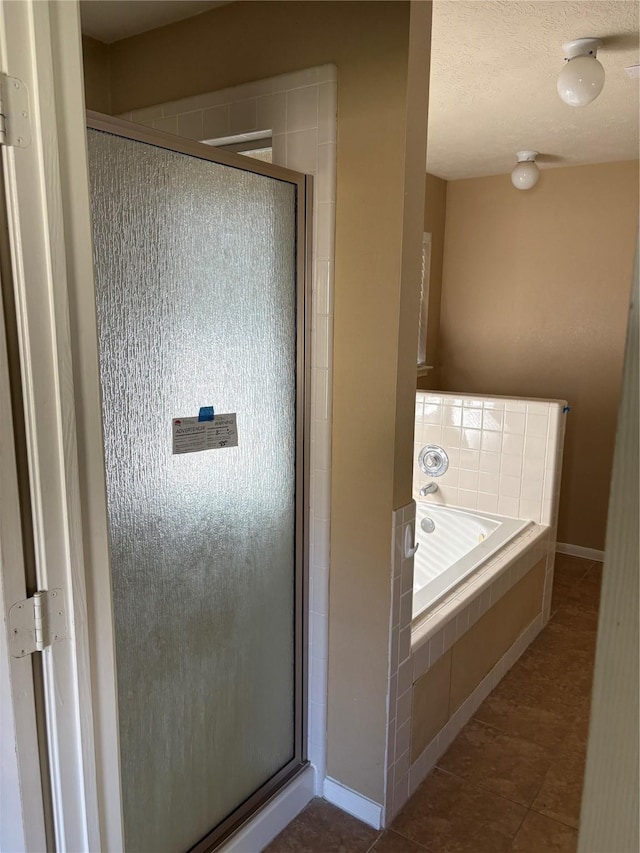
414 391 566 527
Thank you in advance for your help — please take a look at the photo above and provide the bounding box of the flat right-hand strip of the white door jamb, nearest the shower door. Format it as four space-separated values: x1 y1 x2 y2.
49 2 124 853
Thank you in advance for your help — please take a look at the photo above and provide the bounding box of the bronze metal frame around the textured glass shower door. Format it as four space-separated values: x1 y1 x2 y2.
86 110 313 853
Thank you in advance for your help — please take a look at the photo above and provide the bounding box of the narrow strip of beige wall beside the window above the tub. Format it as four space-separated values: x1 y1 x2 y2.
418 172 447 389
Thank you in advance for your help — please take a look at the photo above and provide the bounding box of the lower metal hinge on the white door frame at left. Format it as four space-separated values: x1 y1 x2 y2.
9 589 67 658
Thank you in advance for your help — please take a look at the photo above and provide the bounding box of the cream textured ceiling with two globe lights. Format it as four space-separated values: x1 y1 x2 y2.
427 0 639 180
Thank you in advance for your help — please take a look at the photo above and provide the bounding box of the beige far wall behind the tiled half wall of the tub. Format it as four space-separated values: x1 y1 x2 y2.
439 161 638 549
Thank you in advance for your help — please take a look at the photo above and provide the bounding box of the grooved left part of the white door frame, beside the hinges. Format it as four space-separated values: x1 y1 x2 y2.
0 0 100 850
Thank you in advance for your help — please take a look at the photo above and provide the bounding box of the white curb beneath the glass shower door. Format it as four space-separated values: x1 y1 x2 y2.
220 765 315 853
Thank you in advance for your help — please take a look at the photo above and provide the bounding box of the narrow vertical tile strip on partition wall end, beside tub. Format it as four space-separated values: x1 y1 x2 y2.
384 501 416 824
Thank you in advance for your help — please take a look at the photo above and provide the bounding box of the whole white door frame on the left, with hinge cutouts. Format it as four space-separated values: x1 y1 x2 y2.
0 0 311 853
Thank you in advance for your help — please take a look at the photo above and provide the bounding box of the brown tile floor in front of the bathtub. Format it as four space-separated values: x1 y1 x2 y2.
267 555 602 853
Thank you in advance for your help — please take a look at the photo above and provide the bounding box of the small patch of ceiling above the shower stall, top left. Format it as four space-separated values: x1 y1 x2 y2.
80 0 230 44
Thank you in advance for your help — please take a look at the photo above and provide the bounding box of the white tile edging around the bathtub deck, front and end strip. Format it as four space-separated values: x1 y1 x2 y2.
384 501 551 825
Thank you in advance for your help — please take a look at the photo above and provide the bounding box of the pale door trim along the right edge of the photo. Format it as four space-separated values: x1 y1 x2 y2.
578 241 640 853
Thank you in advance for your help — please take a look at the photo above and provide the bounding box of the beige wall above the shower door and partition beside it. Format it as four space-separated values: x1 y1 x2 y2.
81 2 431 803
